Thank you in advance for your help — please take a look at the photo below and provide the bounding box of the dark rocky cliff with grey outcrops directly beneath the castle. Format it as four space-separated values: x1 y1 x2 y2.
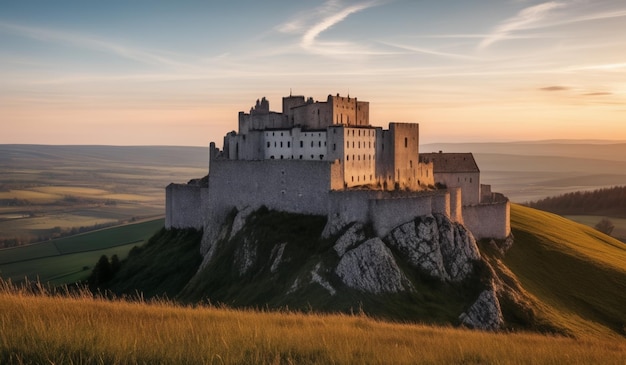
177 208 503 330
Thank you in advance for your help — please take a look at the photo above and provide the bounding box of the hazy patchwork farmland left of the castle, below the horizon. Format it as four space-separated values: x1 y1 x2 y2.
0 145 208 248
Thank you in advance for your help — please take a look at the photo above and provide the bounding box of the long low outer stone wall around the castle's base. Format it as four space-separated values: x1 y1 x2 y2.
166 159 510 240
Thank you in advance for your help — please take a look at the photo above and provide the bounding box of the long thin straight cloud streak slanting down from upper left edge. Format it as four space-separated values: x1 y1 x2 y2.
0 21 190 68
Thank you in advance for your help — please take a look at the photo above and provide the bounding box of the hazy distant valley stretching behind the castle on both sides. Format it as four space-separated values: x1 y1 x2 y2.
0 141 626 246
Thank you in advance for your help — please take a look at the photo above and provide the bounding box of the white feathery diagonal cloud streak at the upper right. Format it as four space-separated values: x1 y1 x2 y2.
478 1 565 49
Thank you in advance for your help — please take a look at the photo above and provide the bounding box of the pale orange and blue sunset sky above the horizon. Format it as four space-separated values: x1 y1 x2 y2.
0 0 626 146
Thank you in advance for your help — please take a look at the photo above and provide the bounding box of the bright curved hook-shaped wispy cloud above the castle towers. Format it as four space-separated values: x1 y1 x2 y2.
277 0 387 53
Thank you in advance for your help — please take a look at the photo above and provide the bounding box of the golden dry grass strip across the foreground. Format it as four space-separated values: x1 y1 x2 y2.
0 283 626 364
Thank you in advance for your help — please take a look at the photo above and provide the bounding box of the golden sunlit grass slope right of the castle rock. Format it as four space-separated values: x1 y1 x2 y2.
502 204 626 335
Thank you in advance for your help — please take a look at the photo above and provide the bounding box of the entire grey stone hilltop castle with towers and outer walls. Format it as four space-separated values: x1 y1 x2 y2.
165 94 510 247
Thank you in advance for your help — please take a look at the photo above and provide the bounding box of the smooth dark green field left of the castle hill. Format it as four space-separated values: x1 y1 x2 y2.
0 219 163 285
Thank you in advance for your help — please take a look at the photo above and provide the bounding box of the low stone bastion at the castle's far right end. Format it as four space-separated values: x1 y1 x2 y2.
463 199 511 240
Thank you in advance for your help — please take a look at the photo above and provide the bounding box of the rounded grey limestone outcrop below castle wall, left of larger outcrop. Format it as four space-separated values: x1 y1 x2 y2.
335 237 413 294
